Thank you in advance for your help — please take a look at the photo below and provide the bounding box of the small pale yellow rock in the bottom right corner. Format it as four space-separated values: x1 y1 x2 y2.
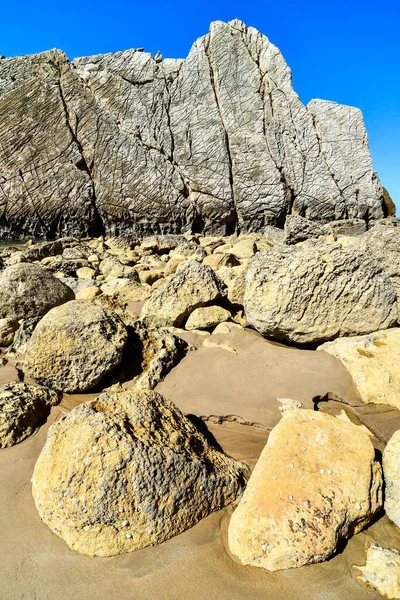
352 544 400 600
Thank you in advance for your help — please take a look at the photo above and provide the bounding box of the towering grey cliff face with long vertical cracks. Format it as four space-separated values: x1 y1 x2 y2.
0 20 384 237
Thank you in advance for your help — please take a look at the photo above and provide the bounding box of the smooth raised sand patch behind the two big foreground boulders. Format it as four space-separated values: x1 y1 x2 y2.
157 329 359 429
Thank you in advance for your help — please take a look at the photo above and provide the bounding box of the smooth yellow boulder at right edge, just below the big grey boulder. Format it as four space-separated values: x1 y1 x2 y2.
318 328 400 409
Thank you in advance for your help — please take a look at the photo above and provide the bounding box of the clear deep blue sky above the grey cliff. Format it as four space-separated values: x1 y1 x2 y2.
0 0 400 213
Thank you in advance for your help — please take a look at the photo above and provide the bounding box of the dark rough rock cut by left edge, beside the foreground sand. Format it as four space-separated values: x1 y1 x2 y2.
0 382 58 448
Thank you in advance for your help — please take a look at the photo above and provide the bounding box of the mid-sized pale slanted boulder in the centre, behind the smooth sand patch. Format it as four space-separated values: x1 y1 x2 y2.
141 260 223 327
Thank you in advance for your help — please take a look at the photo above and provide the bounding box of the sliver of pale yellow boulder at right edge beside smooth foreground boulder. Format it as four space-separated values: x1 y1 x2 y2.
382 430 400 527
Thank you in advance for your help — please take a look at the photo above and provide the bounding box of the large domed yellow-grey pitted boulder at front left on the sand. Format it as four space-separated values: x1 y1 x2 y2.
32 390 245 556
